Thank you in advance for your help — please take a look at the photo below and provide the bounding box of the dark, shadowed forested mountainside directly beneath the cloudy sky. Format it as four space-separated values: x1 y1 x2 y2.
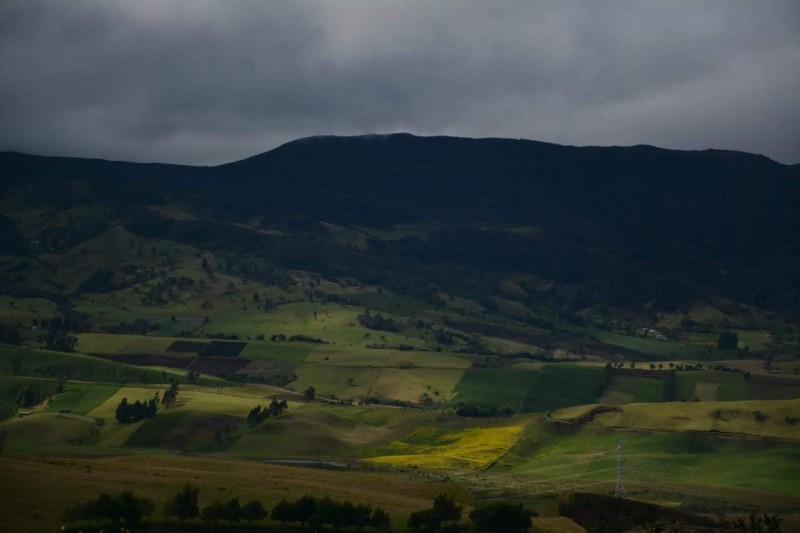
0 134 800 313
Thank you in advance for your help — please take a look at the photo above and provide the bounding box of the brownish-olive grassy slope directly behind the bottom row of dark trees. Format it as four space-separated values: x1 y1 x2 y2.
0 455 474 531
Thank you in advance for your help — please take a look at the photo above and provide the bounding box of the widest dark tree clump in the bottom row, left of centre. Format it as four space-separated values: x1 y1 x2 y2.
270 495 389 530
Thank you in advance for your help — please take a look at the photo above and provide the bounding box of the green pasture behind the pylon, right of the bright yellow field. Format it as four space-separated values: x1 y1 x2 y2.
490 420 800 494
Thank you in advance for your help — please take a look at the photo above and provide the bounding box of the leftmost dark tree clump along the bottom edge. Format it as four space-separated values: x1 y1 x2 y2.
64 491 155 529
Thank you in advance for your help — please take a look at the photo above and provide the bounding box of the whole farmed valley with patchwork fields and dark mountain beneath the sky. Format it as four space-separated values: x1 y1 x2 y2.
0 136 800 531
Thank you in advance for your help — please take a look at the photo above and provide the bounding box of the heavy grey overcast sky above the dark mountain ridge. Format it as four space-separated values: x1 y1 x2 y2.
0 0 800 164
